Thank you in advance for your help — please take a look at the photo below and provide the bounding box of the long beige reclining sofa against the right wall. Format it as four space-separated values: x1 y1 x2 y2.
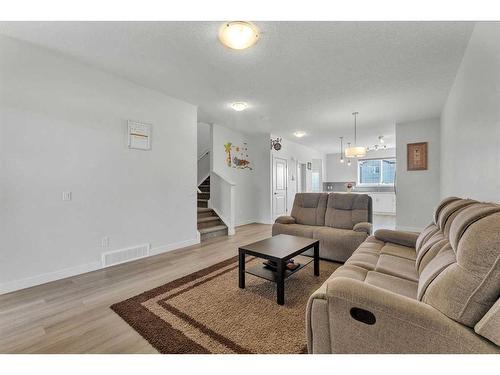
306 197 500 353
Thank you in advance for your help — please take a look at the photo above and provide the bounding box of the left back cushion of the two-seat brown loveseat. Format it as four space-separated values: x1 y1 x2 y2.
292 193 328 225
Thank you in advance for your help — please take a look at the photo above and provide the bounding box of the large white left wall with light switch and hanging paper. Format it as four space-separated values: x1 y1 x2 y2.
0 36 198 292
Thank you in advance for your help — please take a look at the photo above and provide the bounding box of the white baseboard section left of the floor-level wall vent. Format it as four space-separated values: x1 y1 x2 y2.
0 261 102 294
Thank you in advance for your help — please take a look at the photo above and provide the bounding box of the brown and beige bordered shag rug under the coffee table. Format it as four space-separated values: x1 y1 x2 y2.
111 257 339 354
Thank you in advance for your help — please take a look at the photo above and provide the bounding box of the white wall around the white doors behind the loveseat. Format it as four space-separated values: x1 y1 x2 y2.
271 134 325 213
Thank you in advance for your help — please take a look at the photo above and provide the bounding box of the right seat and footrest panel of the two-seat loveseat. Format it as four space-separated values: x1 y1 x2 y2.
313 227 368 262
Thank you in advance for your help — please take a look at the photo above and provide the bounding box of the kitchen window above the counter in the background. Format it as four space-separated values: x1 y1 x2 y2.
358 159 396 185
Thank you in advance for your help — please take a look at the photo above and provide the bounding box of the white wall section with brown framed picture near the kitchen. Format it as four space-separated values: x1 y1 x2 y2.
396 119 440 231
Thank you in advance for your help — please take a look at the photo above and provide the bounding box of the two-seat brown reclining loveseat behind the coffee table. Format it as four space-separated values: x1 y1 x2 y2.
272 193 372 262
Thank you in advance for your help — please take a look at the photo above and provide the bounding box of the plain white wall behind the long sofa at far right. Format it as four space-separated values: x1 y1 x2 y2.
441 22 500 202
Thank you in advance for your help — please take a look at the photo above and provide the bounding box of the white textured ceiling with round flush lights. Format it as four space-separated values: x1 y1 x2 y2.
0 22 474 152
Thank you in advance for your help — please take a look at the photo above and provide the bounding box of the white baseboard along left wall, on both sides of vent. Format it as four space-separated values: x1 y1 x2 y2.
0 238 200 295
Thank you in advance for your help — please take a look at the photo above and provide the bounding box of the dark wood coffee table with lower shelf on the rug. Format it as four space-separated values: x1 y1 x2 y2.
238 234 319 305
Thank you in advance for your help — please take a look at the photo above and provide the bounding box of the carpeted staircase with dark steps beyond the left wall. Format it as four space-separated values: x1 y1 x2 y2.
198 176 227 241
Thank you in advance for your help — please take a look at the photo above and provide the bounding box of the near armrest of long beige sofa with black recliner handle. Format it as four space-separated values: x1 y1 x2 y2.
306 277 500 353
